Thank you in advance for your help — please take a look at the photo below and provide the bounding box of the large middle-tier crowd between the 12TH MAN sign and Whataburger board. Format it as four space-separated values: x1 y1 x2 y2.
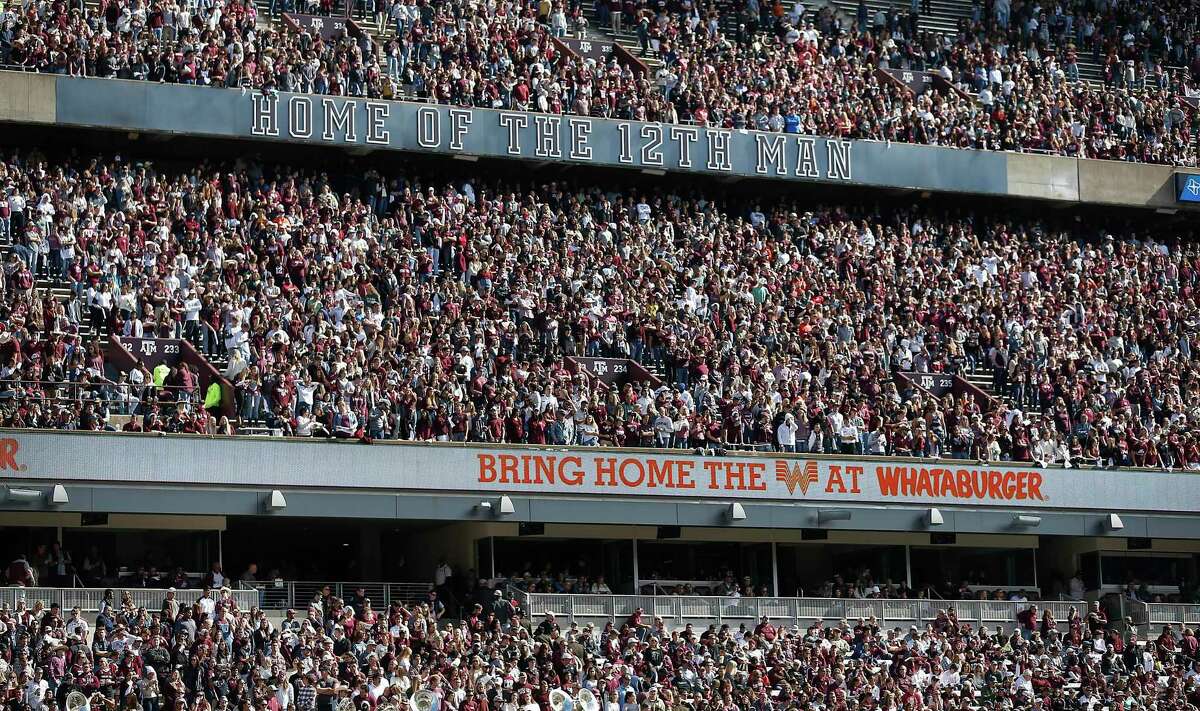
0 145 1200 468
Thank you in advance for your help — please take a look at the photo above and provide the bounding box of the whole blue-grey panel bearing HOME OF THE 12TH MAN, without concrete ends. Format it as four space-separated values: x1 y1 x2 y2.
55 77 1008 195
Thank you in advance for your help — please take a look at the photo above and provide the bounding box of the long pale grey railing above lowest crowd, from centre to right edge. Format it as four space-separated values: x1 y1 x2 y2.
520 591 1200 629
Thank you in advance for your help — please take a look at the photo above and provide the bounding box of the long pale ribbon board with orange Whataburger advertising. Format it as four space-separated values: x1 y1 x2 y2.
0 430 1200 513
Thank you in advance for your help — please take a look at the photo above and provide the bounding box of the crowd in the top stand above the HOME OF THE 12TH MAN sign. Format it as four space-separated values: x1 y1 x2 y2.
0 0 1200 165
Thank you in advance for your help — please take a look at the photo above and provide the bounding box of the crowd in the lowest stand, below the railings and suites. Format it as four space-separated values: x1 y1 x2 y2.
0 576 1200 711
